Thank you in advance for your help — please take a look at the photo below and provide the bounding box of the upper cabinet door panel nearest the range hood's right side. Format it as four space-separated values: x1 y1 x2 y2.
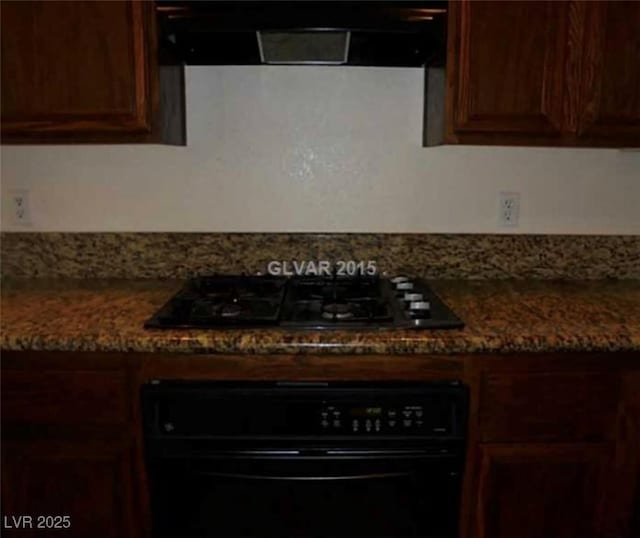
448 1 568 140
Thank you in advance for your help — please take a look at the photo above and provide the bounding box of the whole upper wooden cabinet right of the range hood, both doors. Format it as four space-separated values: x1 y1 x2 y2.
445 0 640 146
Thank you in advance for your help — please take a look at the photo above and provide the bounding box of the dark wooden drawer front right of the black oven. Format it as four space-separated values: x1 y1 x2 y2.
478 372 619 442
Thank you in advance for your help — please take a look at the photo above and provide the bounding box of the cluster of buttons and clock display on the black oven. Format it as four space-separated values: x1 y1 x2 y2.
317 404 454 435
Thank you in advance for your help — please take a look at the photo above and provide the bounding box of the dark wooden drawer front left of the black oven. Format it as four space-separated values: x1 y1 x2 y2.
2 370 129 425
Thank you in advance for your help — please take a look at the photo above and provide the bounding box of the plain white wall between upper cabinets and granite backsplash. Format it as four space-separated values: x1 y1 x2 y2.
2 66 640 234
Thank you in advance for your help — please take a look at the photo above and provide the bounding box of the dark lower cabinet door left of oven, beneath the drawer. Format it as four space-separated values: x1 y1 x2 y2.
2 439 141 538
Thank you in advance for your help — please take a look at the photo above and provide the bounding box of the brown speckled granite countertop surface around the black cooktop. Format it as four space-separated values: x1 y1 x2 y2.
0 280 640 354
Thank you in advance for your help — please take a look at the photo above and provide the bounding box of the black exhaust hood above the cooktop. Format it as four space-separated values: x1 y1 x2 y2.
157 0 447 67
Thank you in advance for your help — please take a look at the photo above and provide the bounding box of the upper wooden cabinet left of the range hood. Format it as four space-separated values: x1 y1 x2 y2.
1 0 184 144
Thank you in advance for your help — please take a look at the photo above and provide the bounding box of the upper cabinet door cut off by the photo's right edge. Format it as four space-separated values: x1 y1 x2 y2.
579 1 640 142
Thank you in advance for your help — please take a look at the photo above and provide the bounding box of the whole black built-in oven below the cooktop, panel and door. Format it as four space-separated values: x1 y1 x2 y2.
142 381 467 538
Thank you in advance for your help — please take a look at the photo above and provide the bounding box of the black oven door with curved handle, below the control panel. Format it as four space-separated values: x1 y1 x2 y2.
149 450 461 538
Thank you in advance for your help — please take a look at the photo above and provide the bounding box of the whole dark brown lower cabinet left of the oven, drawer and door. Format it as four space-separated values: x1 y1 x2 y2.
2 353 144 538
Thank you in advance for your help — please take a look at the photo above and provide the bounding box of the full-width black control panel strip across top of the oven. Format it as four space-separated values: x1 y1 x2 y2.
143 380 468 439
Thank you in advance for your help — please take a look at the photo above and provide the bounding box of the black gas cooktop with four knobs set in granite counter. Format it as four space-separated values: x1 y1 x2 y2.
145 276 464 330
